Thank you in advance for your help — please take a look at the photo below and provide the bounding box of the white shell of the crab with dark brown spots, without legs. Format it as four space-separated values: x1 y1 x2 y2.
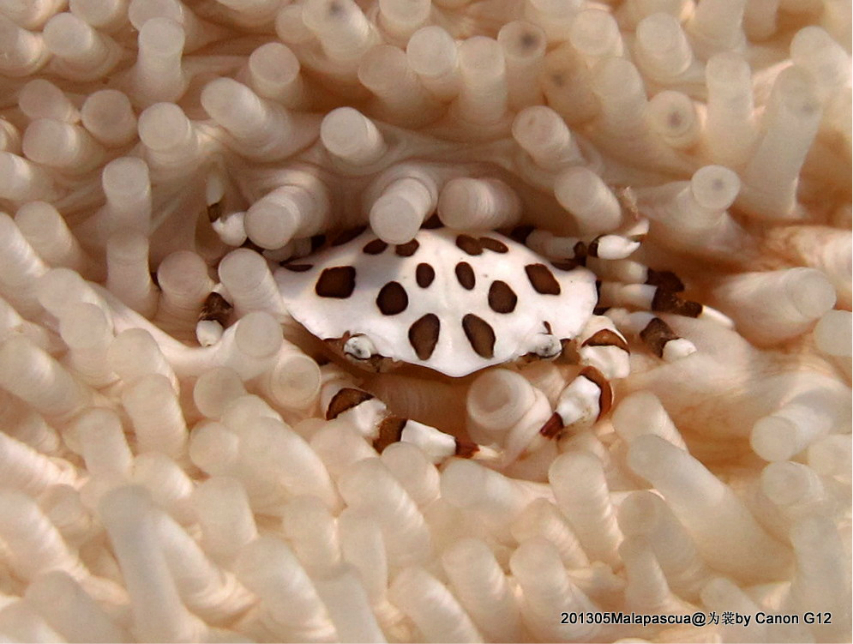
275 228 598 377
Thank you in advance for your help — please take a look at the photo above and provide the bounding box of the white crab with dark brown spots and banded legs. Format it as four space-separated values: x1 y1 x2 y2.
251 216 724 465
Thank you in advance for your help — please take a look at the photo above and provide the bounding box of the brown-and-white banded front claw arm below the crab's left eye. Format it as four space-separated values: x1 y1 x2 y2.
320 369 499 463
